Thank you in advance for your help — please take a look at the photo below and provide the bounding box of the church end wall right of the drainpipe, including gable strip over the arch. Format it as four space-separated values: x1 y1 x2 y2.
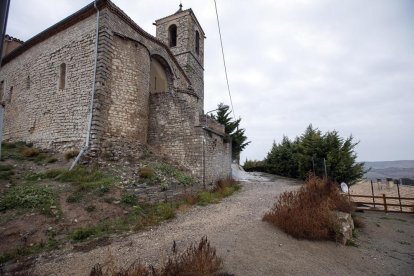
87 8 194 156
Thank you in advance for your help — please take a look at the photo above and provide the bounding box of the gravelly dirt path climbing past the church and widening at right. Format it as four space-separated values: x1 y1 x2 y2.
36 174 414 275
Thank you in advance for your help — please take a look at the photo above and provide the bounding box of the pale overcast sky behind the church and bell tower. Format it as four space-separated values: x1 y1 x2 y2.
7 0 414 161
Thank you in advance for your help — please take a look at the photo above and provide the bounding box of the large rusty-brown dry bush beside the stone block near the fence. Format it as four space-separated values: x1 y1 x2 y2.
263 177 353 240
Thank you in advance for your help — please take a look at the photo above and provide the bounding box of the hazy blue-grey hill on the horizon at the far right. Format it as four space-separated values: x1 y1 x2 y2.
364 160 414 184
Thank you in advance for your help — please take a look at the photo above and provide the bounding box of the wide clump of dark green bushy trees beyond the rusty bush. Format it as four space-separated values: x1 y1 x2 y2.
265 125 365 184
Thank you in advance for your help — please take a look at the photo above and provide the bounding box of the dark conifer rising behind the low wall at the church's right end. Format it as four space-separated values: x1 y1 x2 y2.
212 103 250 163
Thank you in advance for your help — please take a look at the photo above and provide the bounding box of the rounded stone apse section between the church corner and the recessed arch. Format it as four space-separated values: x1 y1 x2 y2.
98 36 150 156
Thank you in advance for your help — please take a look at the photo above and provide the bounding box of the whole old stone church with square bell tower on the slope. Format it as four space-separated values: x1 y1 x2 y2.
0 0 231 185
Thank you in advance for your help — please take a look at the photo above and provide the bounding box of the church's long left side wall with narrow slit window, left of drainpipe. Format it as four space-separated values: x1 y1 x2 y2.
0 15 96 150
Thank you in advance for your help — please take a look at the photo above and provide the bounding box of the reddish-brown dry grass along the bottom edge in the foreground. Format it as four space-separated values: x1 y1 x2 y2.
90 237 226 276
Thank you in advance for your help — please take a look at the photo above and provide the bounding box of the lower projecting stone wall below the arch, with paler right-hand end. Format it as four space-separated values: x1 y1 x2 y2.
148 93 231 188
